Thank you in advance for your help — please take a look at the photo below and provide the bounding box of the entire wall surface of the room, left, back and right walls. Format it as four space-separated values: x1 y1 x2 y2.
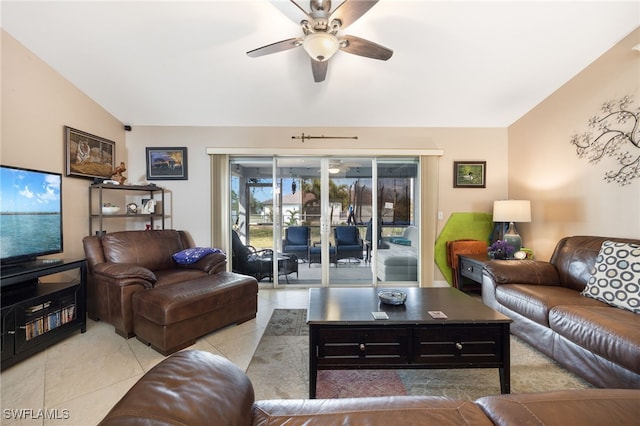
0 24 640 280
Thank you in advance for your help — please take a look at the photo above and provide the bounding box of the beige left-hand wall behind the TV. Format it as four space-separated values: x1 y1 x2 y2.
0 30 126 258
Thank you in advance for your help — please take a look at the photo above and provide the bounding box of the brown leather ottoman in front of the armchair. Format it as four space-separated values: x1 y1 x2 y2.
132 272 258 355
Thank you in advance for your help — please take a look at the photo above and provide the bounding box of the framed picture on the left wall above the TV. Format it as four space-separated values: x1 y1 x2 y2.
64 126 116 179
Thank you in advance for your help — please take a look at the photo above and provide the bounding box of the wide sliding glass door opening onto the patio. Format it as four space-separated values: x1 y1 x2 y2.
229 156 420 286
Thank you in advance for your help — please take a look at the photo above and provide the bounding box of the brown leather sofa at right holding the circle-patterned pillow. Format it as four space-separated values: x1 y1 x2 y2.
482 236 640 389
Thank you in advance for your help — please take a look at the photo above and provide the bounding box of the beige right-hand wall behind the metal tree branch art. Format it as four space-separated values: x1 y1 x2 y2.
508 29 640 260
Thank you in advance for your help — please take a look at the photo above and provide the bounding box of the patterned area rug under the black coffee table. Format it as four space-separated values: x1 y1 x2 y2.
247 309 591 400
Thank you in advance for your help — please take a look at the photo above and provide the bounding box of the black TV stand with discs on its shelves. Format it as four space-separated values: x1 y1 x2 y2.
0 259 87 370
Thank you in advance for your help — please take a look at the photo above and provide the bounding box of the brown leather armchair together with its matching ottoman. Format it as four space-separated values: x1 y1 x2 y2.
83 230 258 354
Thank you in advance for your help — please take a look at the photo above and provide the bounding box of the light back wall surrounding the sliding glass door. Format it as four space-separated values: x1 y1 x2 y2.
127 126 507 264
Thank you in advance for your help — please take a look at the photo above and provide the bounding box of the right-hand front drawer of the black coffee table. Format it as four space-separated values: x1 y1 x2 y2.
413 325 503 366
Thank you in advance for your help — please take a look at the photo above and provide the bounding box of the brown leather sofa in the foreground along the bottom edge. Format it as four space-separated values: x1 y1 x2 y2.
100 351 640 426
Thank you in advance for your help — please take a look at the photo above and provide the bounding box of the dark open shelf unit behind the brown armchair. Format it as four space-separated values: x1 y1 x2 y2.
89 183 165 235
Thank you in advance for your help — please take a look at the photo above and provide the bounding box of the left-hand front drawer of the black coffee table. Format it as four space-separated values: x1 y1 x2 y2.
316 327 410 366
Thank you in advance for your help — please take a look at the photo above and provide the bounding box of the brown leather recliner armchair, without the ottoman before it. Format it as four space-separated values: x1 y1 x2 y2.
83 230 227 338
